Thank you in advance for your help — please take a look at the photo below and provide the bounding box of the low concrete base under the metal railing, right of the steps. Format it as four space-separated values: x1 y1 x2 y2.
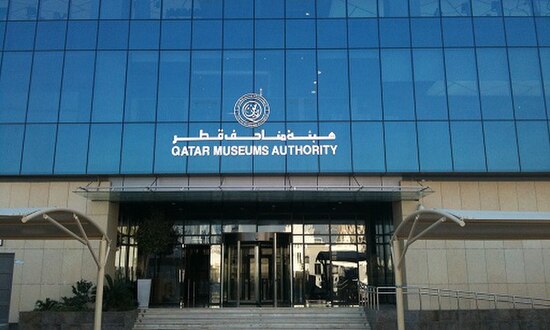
366 308 550 330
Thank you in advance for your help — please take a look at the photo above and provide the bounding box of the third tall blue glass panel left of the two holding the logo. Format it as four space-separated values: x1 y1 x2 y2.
124 51 158 122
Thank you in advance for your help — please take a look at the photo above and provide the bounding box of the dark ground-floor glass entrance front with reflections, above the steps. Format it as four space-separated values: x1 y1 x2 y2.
115 202 393 307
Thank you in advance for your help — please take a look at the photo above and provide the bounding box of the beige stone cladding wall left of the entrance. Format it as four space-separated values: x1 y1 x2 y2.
0 179 118 322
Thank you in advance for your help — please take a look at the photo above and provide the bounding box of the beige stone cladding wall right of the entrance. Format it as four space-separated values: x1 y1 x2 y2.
396 178 550 308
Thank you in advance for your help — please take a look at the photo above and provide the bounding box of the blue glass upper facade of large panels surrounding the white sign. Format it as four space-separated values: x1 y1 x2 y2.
0 0 550 175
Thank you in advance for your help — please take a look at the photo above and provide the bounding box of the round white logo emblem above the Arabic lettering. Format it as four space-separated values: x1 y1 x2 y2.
233 93 269 127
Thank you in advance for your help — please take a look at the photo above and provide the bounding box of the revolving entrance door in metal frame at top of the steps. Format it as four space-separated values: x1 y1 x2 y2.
222 233 291 306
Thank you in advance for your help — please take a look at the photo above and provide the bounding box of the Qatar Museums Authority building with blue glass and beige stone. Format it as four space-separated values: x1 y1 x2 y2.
0 0 550 322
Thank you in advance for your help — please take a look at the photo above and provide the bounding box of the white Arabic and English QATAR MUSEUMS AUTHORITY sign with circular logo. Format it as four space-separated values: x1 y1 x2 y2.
172 90 338 157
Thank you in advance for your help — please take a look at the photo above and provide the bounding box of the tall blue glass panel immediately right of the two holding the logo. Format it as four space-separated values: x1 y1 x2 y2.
286 50 318 120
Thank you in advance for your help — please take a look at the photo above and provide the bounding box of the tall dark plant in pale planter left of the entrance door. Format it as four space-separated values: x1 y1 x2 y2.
136 210 177 309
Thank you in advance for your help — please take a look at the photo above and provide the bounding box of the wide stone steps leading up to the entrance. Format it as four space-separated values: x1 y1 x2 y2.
134 307 370 330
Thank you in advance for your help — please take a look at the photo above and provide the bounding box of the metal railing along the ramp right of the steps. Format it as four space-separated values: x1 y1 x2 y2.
359 283 550 310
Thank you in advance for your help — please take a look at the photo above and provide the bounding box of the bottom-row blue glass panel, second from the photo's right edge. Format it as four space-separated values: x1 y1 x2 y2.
483 121 519 172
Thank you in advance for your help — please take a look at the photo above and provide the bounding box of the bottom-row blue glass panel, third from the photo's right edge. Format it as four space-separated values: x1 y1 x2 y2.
451 121 487 172
